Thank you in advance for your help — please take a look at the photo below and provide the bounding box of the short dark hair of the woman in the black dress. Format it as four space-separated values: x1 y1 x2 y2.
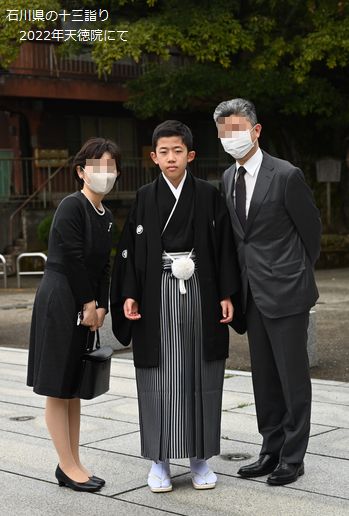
72 137 121 188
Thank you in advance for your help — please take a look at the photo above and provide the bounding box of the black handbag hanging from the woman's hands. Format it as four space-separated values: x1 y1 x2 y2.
76 330 113 400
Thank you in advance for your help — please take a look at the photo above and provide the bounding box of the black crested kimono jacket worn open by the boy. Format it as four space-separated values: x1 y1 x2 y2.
110 174 239 367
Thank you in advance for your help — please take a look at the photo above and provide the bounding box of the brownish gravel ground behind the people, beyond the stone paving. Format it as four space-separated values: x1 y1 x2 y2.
0 268 349 381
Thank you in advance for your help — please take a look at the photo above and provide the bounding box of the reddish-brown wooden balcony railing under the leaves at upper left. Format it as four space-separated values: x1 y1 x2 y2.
2 42 141 82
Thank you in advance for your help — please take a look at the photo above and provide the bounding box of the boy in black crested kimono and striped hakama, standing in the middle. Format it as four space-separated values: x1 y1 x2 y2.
111 120 238 492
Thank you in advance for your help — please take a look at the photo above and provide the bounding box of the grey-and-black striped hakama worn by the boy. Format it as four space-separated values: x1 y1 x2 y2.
136 253 225 461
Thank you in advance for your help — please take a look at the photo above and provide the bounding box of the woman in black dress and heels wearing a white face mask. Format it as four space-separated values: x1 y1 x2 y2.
27 138 120 491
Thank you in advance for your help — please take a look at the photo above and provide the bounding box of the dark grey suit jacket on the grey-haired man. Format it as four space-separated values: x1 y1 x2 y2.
222 152 321 318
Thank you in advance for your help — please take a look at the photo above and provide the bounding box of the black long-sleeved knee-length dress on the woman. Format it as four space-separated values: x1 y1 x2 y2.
27 192 112 399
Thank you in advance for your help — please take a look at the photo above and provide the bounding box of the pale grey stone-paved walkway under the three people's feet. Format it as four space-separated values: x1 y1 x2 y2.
0 348 349 516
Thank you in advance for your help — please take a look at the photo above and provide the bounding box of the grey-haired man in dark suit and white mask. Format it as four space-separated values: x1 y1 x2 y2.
214 99 321 485
